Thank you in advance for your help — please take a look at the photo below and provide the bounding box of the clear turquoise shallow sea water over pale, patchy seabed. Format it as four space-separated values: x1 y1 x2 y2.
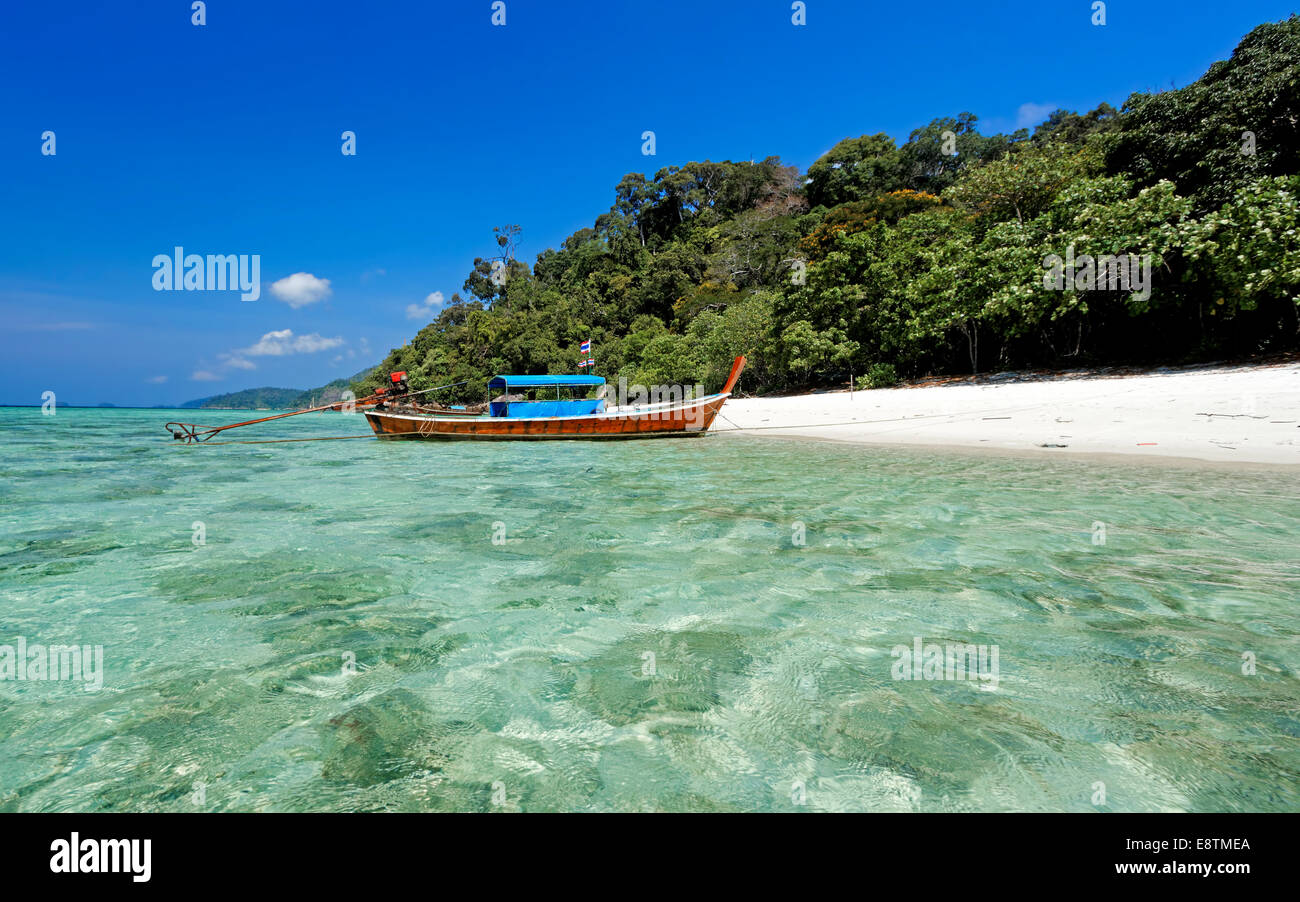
0 408 1300 811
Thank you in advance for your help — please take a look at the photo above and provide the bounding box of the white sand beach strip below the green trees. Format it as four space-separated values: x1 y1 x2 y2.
714 361 1300 465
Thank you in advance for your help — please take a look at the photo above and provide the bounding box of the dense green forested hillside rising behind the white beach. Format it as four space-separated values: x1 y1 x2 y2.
355 17 1300 398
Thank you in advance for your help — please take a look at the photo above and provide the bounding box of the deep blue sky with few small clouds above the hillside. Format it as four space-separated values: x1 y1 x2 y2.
0 0 1296 406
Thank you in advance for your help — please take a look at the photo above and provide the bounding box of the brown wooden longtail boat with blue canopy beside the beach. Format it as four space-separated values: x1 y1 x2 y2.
365 357 745 441
